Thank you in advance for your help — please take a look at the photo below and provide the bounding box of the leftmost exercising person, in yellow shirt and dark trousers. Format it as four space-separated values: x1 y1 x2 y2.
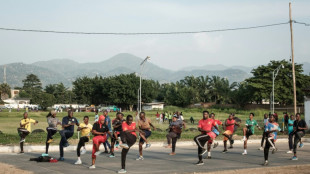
17 112 38 153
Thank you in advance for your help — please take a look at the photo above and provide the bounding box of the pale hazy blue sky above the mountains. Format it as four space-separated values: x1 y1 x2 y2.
0 0 310 70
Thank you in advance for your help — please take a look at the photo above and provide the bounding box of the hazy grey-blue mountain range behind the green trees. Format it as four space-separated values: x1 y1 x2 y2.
0 53 310 87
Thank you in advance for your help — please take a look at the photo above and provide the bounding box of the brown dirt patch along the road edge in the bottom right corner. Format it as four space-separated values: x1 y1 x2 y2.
195 164 310 174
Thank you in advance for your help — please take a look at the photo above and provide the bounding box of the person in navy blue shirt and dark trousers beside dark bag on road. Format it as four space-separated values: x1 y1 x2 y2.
58 110 80 161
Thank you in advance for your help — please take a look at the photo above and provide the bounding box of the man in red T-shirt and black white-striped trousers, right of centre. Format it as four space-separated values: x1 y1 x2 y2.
194 111 216 165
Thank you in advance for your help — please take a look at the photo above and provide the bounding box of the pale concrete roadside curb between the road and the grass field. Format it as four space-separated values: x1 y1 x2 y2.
0 138 310 153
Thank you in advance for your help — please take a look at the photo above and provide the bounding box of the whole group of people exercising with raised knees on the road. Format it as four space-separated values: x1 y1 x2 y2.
18 110 308 173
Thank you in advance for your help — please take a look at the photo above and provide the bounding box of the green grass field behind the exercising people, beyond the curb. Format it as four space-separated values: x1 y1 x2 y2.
0 106 302 145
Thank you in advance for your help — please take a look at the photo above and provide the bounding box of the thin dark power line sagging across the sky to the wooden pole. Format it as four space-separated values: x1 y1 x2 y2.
0 21 290 35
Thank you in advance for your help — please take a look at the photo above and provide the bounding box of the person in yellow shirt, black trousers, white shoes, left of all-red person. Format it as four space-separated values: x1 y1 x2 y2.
74 116 93 164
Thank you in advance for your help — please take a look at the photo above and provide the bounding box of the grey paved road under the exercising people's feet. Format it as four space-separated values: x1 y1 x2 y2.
0 143 310 174
